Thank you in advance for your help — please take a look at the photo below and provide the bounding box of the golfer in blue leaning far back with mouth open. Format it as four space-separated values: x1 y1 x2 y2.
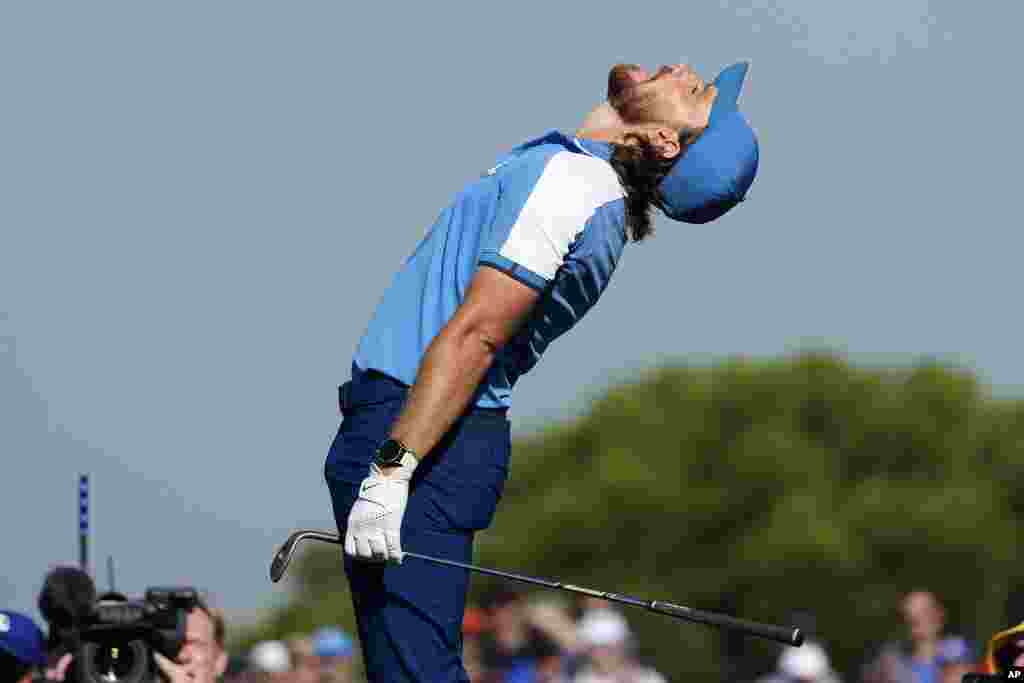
325 63 758 683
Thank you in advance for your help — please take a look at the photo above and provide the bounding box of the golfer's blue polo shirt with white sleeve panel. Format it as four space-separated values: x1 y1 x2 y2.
354 131 626 408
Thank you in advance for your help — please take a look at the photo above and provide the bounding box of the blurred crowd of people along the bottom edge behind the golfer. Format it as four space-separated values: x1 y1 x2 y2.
6 577 1024 683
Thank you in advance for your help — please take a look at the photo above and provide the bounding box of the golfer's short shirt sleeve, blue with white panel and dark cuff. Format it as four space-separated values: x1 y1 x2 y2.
479 152 625 290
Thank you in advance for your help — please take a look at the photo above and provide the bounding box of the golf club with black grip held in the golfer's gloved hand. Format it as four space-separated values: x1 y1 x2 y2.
270 529 804 647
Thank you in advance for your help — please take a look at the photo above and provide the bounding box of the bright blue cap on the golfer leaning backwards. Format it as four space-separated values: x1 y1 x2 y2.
658 61 758 223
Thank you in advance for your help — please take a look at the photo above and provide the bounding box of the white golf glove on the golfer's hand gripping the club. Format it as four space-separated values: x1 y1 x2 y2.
345 455 419 564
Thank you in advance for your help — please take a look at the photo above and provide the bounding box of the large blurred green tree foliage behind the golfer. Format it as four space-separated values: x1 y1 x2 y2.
237 353 1024 680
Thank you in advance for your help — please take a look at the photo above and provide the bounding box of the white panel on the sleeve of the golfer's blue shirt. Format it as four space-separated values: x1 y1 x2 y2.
499 152 626 281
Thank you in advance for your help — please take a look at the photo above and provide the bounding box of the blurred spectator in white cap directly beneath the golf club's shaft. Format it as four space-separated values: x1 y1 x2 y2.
572 608 665 683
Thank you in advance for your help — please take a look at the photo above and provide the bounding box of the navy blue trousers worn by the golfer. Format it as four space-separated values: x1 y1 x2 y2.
324 367 511 683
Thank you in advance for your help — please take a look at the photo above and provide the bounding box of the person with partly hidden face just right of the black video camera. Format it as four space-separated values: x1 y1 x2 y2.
155 600 227 683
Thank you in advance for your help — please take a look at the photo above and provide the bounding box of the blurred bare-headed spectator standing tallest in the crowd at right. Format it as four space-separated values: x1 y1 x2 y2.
864 591 956 683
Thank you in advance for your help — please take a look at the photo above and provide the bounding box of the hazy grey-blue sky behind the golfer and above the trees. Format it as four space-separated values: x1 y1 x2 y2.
0 0 1024 626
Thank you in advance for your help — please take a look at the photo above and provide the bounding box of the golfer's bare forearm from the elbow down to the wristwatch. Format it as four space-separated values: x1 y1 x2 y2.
390 330 496 458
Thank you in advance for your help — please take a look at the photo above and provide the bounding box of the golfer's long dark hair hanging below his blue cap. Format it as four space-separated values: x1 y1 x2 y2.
608 128 703 242
